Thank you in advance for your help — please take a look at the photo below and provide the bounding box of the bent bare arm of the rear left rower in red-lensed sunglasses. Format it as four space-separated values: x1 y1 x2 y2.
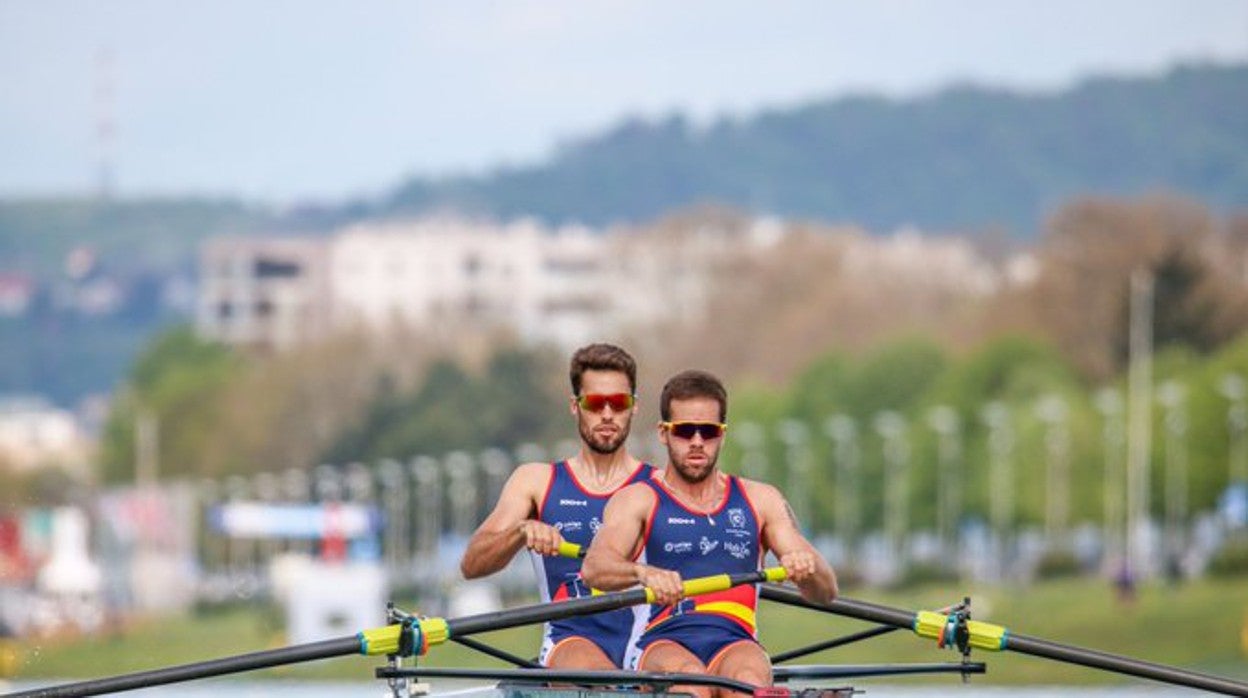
459 463 563 579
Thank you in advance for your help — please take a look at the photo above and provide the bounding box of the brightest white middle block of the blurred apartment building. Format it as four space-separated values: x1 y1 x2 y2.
328 219 615 346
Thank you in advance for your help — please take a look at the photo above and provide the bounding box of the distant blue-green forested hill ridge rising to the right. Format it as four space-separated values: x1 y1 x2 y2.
377 65 1248 237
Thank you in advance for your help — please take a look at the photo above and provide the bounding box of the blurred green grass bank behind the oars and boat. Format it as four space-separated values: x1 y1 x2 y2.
9 579 1248 684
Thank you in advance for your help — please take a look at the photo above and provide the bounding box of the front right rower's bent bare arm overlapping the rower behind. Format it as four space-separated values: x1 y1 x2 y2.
580 483 681 603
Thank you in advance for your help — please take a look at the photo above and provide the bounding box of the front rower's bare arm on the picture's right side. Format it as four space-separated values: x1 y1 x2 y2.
745 481 837 603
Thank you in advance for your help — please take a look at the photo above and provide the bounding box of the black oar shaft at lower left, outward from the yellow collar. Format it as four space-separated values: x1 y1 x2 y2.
5 636 359 698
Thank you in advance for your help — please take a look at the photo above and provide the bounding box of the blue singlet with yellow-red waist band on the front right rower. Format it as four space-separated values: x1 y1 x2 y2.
630 476 763 668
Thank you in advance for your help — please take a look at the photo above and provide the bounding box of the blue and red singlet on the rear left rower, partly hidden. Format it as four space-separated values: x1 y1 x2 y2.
529 461 654 667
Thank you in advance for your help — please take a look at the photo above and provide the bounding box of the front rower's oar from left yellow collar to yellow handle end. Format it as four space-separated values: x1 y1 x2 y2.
357 567 787 656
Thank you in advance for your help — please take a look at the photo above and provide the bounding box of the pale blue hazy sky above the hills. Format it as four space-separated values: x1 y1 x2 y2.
0 0 1248 204
